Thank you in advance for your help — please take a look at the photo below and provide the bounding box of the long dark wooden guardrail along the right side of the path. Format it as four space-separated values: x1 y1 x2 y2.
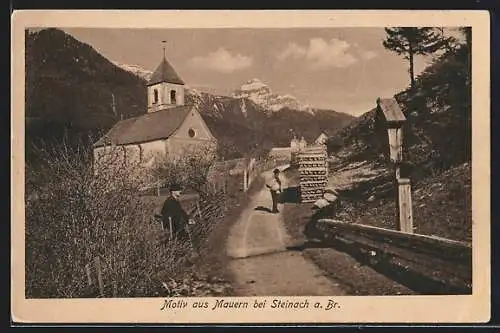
316 219 472 294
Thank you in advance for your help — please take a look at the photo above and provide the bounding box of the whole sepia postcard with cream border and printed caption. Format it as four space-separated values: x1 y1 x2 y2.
12 11 490 322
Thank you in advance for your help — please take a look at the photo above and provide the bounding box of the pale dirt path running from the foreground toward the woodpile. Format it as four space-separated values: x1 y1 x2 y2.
227 167 345 296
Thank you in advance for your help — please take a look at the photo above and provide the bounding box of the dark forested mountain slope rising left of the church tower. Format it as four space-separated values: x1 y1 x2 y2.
25 28 146 140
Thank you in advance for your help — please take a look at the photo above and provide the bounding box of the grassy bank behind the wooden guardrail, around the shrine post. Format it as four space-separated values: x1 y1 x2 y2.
330 163 472 242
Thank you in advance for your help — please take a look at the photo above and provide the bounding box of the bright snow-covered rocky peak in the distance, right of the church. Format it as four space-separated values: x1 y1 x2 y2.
232 79 311 112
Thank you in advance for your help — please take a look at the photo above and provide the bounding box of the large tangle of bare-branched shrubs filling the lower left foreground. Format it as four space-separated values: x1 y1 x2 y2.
25 136 204 298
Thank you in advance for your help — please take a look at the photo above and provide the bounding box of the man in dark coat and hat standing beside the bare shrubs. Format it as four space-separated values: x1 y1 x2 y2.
161 184 191 240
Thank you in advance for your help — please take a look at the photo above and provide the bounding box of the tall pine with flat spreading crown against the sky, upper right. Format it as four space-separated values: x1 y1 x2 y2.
382 27 444 89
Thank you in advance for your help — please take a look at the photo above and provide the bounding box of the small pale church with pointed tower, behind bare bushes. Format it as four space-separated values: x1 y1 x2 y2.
94 53 217 172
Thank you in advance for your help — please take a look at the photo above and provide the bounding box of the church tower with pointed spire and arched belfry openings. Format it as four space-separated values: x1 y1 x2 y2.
147 42 184 113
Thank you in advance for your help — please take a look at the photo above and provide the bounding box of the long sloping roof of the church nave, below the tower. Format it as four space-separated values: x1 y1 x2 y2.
94 106 193 147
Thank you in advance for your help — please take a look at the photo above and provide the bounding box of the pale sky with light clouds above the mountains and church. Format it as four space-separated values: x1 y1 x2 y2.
62 28 460 116
